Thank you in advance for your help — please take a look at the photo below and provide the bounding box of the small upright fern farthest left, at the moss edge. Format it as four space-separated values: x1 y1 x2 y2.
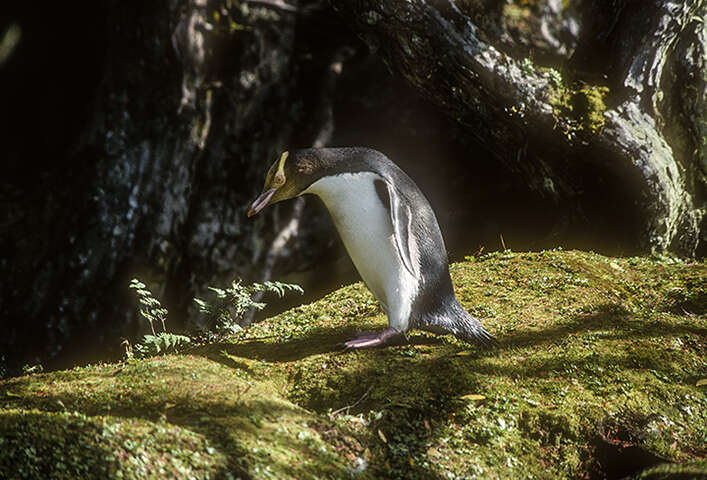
126 278 191 359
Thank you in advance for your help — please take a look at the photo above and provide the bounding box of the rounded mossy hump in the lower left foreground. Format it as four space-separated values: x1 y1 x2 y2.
0 355 354 479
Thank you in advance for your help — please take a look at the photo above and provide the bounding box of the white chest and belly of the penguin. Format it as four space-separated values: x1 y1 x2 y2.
303 172 417 331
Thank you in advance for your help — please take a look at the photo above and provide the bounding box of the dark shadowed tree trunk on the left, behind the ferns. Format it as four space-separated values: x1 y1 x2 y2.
0 0 334 367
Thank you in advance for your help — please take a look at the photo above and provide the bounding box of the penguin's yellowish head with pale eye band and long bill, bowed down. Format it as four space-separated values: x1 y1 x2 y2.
248 150 321 217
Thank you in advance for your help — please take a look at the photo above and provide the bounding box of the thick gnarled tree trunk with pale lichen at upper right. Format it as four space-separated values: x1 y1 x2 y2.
332 0 707 255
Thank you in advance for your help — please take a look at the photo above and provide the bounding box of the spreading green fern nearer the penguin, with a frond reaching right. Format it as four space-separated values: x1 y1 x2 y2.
194 280 304 335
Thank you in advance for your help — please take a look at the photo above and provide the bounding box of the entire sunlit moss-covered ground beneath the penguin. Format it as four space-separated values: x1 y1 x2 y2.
0 251 707 479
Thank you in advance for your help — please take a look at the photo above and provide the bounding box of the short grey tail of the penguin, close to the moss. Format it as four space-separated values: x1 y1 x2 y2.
420 298 498 348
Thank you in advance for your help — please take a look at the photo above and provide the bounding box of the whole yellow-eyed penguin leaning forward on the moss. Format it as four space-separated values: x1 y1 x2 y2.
248 147 495 349
